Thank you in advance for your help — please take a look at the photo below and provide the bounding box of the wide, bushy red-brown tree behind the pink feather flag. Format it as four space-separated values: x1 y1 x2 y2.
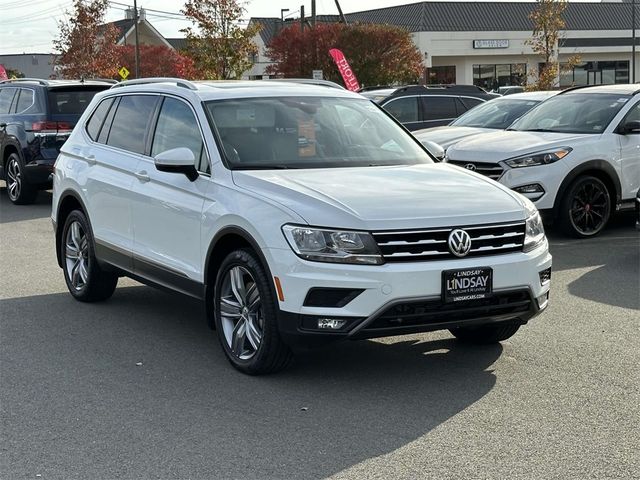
266 23 423 85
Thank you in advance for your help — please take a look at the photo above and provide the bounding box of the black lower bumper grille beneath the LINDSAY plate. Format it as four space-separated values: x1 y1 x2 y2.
362 290 533 332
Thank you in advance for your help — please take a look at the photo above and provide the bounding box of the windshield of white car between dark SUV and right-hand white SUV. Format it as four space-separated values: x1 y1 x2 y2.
450 99 540 130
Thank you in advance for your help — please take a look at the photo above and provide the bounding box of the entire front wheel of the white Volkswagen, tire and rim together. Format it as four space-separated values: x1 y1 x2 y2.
213 249 293 375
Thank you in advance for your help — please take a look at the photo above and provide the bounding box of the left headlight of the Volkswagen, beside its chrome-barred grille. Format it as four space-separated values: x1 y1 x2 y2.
282 225 383 265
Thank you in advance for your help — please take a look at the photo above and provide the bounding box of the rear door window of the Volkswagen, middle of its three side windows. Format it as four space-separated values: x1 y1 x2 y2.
107 95 158 154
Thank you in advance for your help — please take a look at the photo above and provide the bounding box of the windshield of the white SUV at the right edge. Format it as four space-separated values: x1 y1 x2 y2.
511 93 631 134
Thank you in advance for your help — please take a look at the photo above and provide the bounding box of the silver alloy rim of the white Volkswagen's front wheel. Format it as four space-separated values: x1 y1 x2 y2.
219 266 264 360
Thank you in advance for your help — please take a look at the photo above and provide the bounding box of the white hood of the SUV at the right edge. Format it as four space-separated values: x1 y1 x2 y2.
447 130 600 163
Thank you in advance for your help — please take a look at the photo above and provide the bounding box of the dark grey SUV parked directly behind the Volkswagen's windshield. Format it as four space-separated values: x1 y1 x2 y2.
360 85 500 131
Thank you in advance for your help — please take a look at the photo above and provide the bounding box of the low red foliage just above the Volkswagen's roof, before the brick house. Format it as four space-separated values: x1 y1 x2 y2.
117 45 199 79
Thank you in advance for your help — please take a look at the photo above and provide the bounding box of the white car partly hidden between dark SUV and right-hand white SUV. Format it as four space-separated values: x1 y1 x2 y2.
413 92 558 150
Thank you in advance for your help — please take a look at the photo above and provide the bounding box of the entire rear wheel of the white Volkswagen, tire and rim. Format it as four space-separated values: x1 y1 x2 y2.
60 210 118 302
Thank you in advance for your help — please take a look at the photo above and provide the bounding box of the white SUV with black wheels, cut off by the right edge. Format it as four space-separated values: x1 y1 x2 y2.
445 85 640 237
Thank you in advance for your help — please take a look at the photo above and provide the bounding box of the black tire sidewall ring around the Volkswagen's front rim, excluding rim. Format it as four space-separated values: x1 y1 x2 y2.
213 249 279 374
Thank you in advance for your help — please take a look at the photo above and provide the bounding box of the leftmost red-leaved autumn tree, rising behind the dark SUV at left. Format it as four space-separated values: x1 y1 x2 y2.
53 0 118 78
